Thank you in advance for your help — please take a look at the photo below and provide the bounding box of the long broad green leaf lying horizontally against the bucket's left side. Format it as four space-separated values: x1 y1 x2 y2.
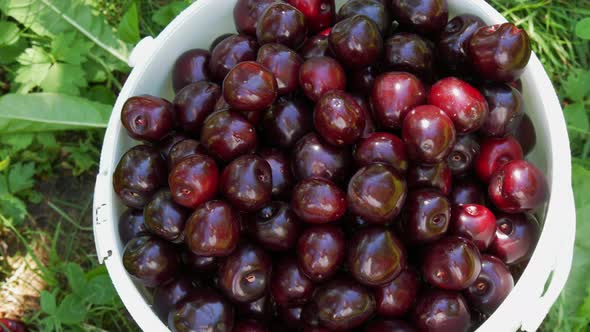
0 93 111 134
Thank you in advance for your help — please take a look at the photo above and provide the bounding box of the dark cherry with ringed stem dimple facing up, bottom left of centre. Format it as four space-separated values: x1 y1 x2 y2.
218 244 272 302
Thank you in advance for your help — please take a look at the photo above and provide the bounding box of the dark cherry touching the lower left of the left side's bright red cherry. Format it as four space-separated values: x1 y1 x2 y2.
143 189 189 242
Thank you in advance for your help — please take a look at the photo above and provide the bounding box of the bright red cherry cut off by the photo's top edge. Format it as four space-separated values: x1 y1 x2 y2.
287 0 336 33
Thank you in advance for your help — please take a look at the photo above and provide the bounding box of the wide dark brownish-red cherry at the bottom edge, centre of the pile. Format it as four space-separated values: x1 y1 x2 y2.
312 280 375 331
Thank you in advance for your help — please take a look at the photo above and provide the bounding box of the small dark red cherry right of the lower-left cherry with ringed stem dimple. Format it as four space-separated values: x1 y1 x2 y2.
270 256 314 306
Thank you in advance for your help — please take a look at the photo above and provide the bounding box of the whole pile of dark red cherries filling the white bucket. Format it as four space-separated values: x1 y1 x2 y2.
113 0 548 332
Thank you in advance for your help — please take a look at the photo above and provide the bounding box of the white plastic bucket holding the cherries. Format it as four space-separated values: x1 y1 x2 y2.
94 0 576 332
